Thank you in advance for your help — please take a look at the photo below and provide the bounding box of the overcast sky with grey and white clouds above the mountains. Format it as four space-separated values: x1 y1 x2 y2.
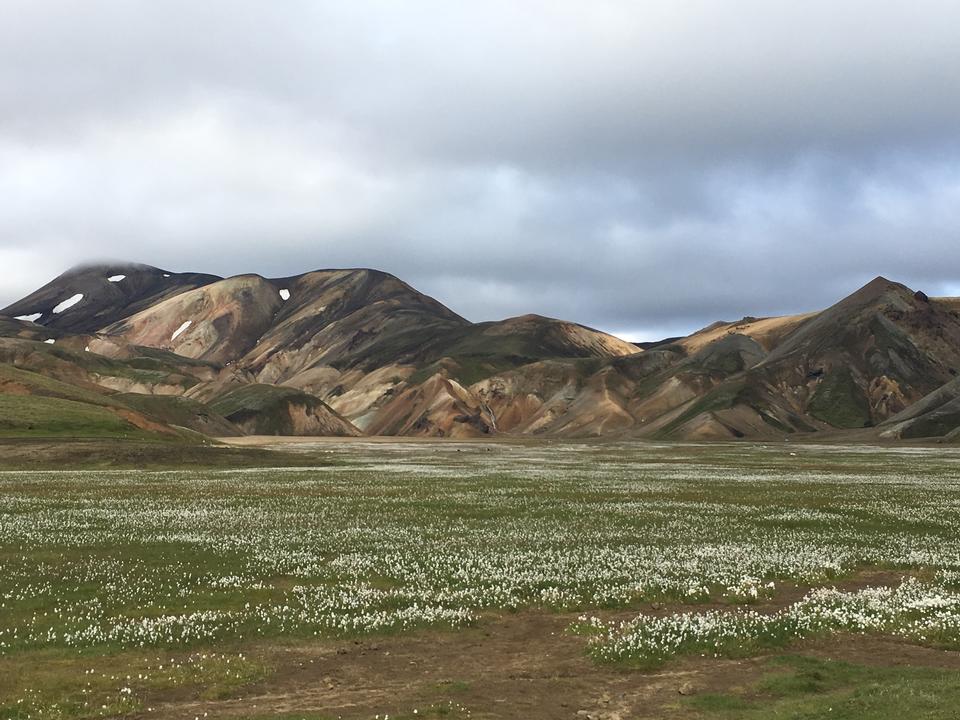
0 0 960 340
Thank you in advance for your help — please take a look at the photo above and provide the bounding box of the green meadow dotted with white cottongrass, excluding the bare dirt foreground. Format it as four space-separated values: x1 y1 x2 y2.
0 443 960 718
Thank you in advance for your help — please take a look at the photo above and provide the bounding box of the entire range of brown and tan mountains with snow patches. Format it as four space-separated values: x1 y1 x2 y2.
0 264 960 439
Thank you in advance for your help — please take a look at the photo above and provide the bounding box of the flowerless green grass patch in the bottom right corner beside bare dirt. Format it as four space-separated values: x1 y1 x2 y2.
686 655 960 720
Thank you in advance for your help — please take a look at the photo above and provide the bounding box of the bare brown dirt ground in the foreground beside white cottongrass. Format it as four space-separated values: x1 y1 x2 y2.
144 600 960 720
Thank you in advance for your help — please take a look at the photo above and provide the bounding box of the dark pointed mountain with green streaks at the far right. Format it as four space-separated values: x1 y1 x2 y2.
616 277 960 437
